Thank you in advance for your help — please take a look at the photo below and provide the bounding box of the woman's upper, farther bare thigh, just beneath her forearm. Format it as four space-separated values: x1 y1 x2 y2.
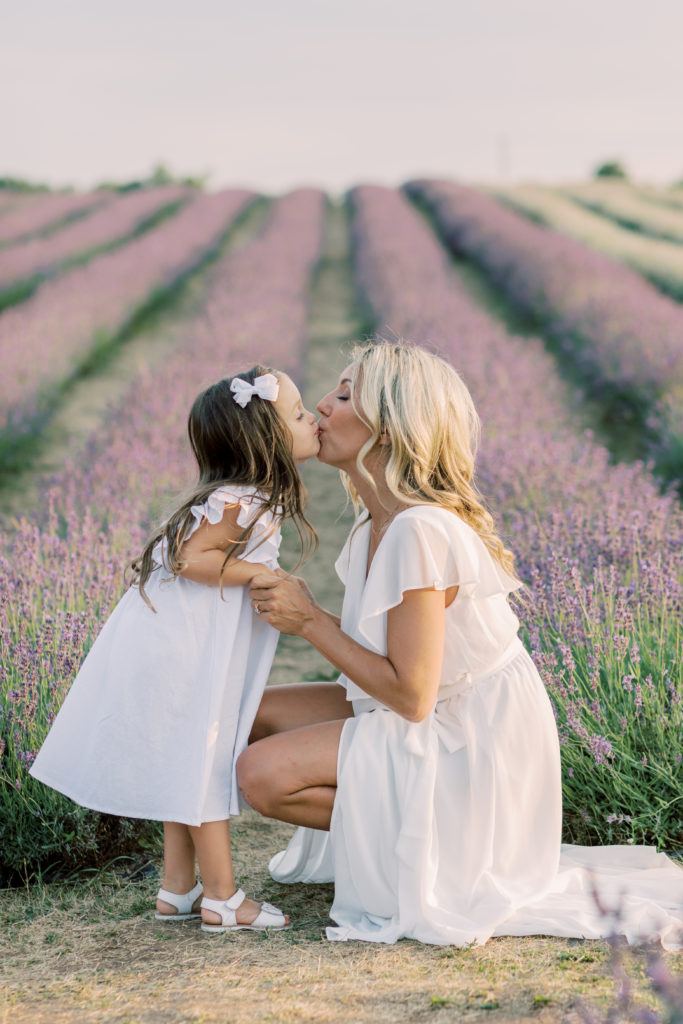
249 683 353 743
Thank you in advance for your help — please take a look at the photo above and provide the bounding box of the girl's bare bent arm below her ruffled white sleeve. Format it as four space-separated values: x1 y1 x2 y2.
179 505 276 587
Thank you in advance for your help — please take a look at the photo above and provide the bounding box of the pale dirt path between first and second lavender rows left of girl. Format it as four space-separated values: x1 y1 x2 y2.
0 196 268 522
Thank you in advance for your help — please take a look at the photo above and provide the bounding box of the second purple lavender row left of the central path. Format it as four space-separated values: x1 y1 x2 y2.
0 189 254 441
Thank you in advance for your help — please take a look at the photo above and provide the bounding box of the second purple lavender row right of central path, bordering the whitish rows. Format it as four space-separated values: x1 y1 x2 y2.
407 181 683 479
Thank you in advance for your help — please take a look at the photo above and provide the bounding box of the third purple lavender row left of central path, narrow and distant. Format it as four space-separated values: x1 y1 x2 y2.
0 185 191 292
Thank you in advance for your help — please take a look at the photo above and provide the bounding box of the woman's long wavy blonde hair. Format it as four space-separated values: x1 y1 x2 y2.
341 338 517 580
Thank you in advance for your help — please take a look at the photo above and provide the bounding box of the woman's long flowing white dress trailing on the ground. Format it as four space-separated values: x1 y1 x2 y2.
270 506 683 948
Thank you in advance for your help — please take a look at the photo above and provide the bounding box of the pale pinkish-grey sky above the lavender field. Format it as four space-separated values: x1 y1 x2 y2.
0 0 683 191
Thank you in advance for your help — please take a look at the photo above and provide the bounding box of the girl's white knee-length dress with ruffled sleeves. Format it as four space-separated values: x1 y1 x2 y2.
31 484 281 825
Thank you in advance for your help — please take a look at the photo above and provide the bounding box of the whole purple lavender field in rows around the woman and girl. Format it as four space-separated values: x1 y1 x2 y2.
0 182 683 880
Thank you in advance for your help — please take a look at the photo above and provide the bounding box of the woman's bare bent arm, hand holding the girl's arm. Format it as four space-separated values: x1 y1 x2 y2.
249 575 446 722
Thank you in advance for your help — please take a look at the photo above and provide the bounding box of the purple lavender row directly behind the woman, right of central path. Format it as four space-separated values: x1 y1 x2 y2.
352 187 683 848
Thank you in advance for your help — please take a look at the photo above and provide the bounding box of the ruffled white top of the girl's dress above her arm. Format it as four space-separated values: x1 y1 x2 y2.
187 483 282 569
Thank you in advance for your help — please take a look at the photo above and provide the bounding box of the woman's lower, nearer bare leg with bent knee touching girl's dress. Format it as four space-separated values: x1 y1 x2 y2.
238 720 345 829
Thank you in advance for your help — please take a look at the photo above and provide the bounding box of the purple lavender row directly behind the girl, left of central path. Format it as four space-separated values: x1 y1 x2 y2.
0 189 325 873
